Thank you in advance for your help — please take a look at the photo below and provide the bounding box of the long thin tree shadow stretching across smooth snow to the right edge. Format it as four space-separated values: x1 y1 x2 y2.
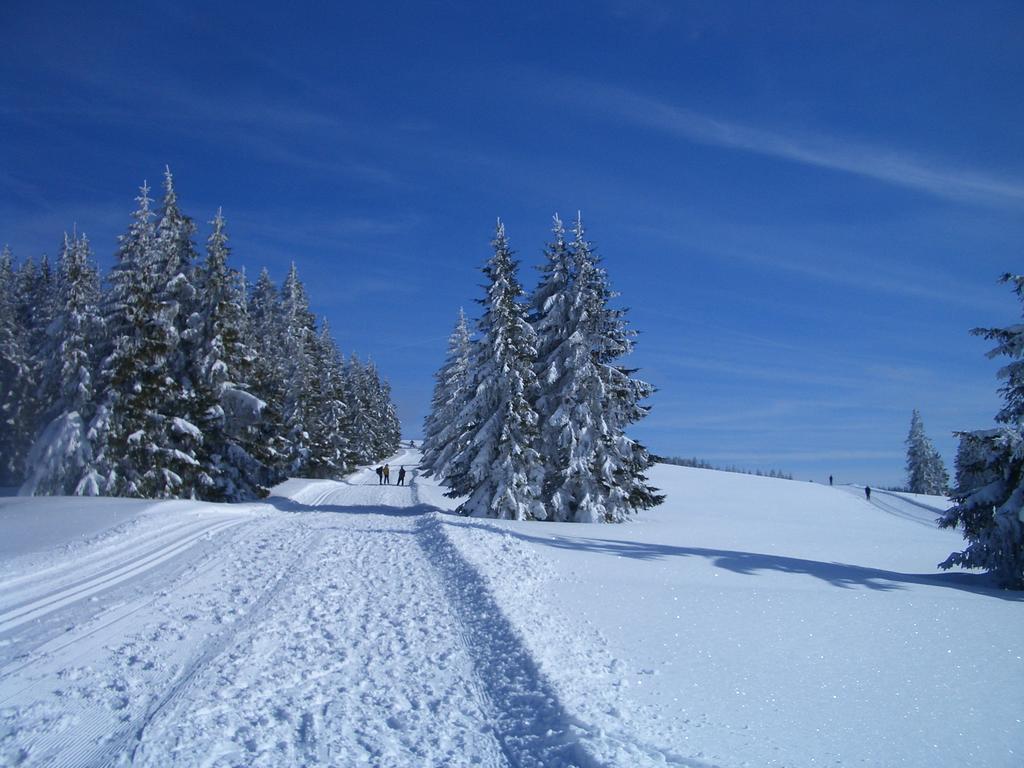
452 522 1024 602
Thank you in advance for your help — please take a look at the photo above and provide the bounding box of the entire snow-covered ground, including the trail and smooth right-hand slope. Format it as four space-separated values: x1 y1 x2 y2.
0 451 1024 768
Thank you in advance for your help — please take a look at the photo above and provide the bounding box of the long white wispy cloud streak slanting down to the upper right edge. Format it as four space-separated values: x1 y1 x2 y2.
553 78 1024 207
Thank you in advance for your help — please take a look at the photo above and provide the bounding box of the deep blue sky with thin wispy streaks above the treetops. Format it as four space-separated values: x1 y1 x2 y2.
0 0 1024 484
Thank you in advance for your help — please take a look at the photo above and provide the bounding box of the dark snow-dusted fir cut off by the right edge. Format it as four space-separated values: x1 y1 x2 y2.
939 273 1024 589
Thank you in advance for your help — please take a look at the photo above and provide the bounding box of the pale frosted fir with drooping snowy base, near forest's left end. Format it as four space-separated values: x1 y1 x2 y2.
20 233 102 496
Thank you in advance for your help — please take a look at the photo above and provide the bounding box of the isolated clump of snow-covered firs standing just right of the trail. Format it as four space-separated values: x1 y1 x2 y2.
423 215 663 522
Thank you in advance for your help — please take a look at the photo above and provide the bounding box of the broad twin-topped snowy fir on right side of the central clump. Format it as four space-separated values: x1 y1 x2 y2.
535 217 663 522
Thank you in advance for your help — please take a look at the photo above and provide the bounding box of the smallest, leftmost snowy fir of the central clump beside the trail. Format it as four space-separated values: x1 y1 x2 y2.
420 309 472 477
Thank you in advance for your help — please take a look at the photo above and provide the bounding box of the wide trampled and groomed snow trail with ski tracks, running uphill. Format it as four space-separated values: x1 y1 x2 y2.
0 454 598 768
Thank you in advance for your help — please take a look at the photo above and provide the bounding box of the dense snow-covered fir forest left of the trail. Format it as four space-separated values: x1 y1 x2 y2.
0 169 400 501
